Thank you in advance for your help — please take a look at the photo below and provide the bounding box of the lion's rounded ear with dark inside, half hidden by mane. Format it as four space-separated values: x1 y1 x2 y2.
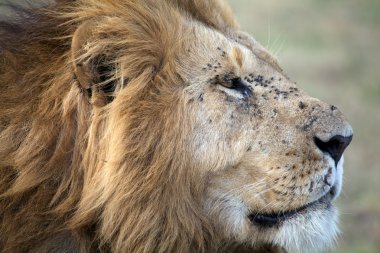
71 20 116 106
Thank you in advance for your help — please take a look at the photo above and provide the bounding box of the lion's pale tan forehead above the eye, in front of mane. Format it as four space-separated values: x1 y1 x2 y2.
183 23 281 75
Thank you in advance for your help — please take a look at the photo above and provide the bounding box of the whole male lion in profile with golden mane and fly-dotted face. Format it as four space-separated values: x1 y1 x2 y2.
0 0 353 253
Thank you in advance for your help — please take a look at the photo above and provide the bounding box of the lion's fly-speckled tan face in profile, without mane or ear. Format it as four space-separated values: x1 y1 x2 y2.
175 25 352 251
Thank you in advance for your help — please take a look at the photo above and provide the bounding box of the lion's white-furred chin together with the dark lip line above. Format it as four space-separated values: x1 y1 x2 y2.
249 186 339 252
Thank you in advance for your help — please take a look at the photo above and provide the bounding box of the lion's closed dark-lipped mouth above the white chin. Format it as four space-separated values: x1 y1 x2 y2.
248 186 336 227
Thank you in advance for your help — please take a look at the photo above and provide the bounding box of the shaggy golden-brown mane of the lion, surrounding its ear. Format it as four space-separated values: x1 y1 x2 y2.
0 0 220 252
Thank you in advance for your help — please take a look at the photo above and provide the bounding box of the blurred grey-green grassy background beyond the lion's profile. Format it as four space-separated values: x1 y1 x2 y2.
229 0 380 253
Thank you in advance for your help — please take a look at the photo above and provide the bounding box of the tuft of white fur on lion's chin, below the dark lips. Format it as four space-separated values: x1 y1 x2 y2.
273 206 340 252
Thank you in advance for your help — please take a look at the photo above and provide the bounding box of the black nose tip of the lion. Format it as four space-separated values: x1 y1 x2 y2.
314 135 352 164
